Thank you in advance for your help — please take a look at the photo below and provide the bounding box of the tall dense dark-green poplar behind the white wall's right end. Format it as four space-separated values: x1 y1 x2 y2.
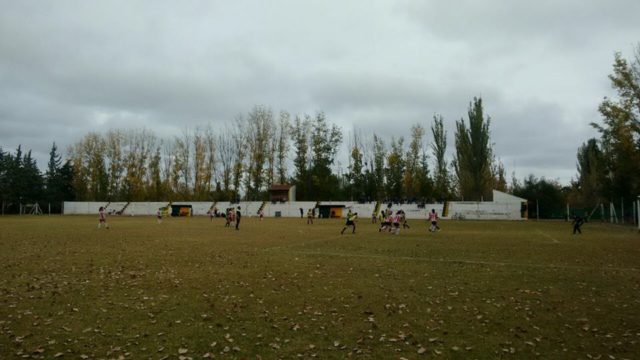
453 98 494 201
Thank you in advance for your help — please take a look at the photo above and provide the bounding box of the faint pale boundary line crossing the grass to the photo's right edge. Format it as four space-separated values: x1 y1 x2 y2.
276 249 640 272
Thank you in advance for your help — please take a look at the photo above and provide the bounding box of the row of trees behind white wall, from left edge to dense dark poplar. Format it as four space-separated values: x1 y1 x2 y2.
0 98 506 210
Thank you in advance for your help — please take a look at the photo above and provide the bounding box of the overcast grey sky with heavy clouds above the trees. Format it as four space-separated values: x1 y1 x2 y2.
0 0 640 184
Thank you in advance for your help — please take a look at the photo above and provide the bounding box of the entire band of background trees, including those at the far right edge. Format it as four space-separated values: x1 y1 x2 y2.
0 44 640 217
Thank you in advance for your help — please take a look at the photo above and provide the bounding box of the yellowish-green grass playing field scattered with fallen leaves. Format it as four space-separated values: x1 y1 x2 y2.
0 216 640 359
